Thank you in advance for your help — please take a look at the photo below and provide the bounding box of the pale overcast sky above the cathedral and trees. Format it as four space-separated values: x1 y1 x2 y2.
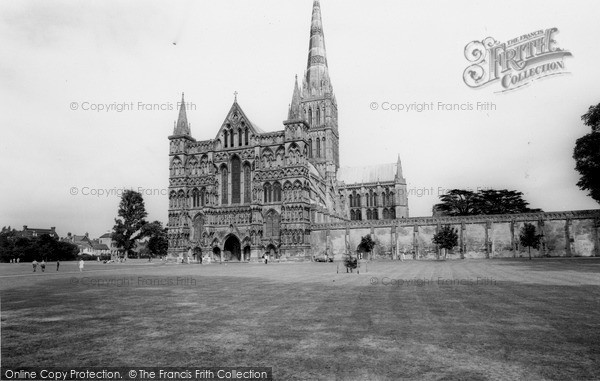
0 0 600 237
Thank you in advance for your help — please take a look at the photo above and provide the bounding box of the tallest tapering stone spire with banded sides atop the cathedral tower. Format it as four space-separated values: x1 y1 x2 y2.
302 0 332 97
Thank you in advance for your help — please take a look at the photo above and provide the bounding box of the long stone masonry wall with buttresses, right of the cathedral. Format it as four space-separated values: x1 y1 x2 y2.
311 210 600 260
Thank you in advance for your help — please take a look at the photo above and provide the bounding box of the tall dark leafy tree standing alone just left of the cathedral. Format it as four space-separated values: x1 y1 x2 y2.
112 190 148 257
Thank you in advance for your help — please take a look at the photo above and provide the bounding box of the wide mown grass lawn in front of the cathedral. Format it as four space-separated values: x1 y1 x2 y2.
0 258 600 380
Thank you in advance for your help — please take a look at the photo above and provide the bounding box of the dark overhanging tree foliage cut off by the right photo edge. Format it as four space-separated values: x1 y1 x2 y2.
573 103 600 203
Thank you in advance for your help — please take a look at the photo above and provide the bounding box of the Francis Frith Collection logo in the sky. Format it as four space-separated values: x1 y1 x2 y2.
463 28 571 92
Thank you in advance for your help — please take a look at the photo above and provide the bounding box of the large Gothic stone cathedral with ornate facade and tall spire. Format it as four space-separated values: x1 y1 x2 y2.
168 0 408 261
